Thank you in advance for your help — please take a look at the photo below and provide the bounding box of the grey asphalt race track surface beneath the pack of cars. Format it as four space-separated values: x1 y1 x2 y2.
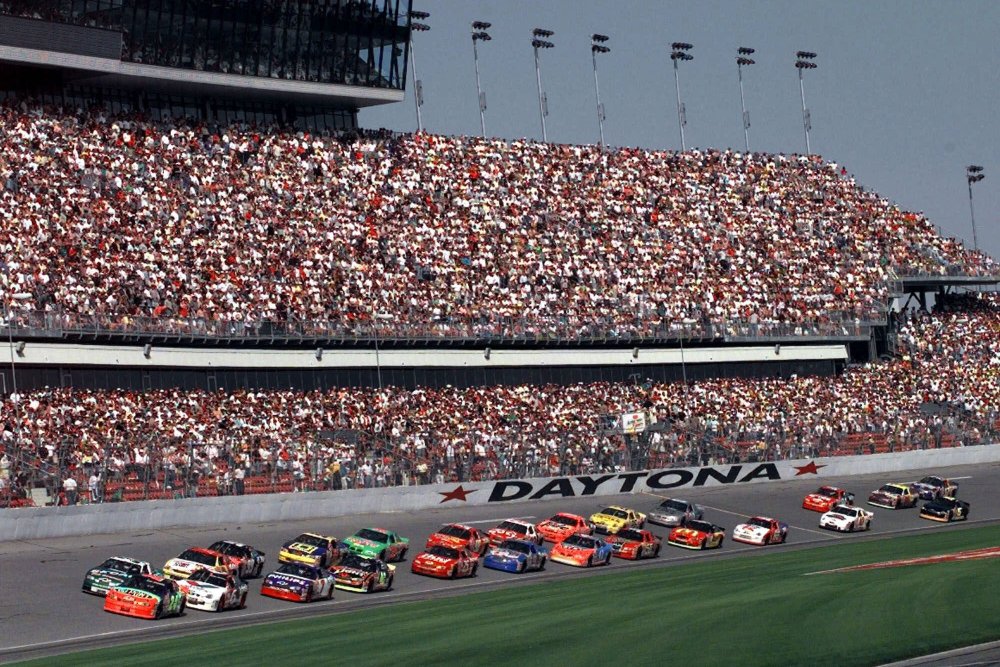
0 464 1000 664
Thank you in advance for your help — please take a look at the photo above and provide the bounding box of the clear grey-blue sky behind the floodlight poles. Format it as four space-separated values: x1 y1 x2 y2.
360 0 1000 264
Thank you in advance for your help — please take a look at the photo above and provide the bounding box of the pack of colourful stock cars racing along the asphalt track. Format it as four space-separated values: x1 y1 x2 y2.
82 476 969 619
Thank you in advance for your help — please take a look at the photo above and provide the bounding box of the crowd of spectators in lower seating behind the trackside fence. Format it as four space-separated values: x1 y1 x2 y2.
0 295 1000 506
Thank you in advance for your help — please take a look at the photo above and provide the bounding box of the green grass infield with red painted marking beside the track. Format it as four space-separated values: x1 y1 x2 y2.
24 526 1000 667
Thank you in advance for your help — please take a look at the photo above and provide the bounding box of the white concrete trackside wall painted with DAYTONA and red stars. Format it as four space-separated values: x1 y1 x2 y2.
0 445 1000 542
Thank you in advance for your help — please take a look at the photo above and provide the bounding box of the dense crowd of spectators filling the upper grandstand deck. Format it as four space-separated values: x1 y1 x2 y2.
0 101 1000 344
